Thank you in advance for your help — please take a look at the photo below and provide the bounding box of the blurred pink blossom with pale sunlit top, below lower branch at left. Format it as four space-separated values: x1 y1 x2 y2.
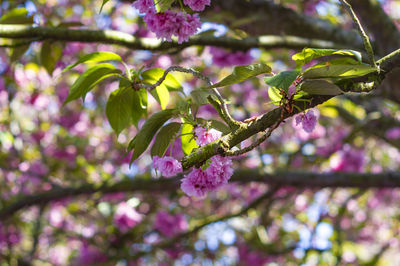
114 202 142 232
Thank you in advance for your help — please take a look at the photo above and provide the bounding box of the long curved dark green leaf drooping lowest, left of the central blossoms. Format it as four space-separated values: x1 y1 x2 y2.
131 109 176 163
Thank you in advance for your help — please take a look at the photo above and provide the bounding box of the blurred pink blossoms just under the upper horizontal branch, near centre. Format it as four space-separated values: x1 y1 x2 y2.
209 47 253 67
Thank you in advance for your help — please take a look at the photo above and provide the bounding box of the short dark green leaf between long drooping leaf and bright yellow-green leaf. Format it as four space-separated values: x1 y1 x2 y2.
151 122 181 157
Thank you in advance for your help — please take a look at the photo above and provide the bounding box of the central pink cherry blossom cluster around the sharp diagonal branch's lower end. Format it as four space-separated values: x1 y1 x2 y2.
153 127 233 198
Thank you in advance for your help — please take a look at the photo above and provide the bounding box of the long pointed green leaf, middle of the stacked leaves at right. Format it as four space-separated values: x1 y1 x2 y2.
303 64 376 79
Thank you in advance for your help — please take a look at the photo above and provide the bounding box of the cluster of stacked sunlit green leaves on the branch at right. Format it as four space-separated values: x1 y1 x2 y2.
265 48 377 108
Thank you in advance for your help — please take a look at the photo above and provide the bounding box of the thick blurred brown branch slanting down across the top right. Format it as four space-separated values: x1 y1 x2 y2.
209 0 363 50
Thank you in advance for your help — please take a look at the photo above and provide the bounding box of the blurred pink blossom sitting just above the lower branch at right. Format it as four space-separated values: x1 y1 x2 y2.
330 145 366 172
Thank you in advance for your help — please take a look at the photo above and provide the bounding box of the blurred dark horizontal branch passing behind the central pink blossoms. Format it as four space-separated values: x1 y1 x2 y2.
0 170 400 220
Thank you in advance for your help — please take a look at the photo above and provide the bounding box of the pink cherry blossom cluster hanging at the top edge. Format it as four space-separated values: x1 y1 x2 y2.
133 0 210 43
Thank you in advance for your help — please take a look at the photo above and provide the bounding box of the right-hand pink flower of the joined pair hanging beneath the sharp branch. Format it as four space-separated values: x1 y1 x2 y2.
205 155 233 188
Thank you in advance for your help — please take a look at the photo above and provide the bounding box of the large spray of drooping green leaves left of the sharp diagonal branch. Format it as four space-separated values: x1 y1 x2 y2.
63 52 271 161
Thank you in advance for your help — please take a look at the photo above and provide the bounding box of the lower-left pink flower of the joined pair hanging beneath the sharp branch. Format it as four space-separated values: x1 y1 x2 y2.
181 168 214 198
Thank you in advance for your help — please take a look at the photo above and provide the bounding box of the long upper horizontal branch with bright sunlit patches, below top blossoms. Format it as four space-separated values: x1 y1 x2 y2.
0 24 360 51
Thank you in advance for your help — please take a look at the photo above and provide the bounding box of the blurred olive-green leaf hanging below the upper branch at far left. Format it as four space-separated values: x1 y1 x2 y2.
40 41 64 76
